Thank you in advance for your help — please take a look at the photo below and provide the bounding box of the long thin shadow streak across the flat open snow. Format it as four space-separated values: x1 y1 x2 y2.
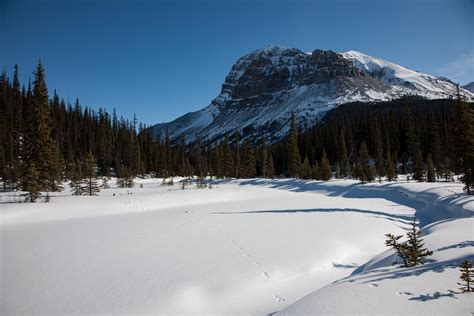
210 208 413 224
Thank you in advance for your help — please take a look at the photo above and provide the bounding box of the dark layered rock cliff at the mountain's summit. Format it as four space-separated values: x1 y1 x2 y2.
221 47 364 101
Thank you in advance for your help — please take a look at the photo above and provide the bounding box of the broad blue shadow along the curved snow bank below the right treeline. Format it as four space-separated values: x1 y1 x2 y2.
240 179 473 227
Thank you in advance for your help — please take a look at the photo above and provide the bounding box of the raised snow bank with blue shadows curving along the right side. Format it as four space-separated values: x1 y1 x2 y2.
268 183 474 315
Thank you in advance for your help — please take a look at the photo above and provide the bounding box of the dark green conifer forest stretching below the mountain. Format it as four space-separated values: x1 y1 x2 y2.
0 63 474 200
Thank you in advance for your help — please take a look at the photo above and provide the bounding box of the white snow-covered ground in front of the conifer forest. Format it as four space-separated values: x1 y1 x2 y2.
0 179 474 315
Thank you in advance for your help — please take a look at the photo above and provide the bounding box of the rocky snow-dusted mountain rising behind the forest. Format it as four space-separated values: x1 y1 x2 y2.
152 46 474 141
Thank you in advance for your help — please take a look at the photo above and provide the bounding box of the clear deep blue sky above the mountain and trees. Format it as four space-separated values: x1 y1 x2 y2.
0 0 474 124
